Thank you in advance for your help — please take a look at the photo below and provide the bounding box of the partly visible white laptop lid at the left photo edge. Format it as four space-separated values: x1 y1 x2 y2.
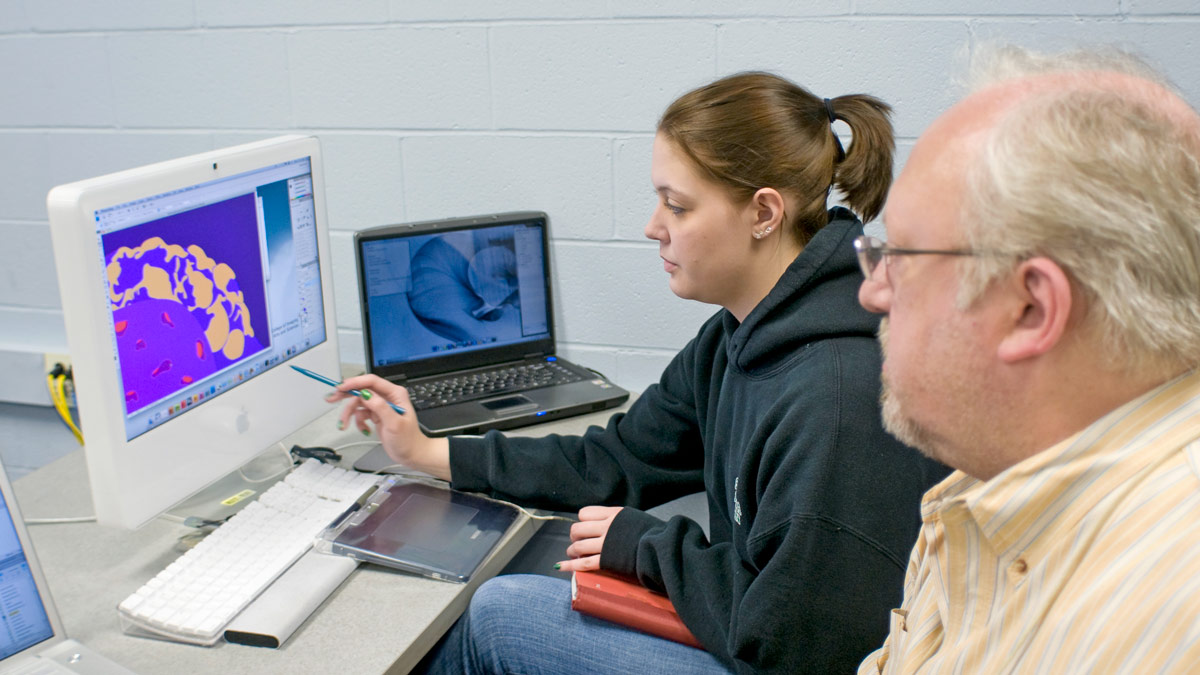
0 465 67 669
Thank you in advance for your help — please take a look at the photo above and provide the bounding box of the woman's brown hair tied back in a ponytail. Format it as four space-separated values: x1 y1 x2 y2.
658 72 895 246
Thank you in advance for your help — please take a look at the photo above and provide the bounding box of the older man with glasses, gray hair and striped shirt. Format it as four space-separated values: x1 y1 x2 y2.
857 44 1200 673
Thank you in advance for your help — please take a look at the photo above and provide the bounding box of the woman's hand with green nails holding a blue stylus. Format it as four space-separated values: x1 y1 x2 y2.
325 375 450 480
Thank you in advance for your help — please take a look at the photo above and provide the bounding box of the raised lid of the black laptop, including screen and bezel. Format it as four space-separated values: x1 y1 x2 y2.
354 211 554 381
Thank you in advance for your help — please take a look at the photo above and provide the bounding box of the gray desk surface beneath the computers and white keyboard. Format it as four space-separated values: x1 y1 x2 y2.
14 396 633 675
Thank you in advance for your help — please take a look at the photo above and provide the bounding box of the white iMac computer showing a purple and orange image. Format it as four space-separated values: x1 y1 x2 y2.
47 136 338 528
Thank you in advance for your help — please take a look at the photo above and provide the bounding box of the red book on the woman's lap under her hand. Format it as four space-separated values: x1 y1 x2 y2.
571 572 704 650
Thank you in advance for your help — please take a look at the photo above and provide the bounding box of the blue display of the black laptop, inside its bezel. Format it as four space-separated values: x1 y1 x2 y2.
362 225 550 368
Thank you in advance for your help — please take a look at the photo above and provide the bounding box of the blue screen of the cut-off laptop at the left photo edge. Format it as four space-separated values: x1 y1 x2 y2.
0 487 54 658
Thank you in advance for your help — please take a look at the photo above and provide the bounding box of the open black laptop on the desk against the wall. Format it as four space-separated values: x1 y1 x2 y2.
354 211 629 436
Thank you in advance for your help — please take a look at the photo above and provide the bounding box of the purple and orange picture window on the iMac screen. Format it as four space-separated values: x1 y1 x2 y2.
101 193 270 414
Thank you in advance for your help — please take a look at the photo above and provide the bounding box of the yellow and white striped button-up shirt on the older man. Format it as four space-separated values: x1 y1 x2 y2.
859 372 1200 675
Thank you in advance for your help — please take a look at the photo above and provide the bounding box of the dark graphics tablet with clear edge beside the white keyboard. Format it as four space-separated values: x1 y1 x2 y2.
314 477 517 584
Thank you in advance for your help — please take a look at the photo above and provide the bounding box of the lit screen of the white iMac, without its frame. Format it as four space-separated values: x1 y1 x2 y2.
96 157 325 438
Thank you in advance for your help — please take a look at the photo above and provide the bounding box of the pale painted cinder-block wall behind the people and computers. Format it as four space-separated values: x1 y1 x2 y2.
0 0 1200 401
